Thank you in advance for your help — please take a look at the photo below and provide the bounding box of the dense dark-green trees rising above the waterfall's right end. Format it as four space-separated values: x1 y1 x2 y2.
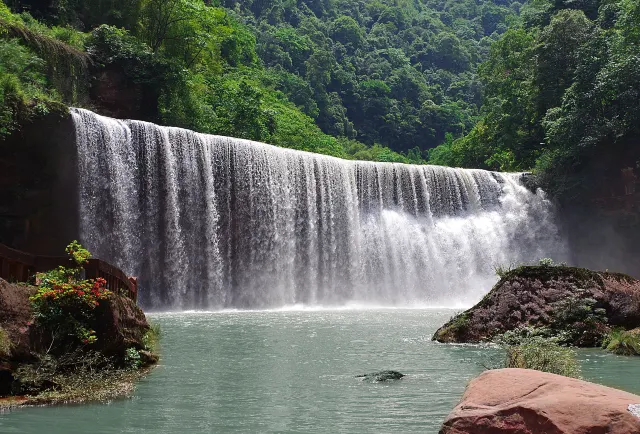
430 0 640 200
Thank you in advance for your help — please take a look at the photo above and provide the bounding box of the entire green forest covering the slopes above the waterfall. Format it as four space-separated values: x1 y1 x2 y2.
0 0 640 200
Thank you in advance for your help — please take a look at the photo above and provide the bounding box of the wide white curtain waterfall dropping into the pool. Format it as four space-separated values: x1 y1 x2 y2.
72 109 565 309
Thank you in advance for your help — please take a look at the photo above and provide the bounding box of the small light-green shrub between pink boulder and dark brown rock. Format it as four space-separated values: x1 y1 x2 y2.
505 336 580 378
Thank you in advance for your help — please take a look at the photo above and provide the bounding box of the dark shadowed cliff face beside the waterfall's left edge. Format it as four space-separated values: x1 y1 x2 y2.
0 105 80 255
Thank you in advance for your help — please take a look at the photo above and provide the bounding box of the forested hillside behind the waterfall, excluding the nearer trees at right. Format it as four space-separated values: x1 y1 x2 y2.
0 0 521 163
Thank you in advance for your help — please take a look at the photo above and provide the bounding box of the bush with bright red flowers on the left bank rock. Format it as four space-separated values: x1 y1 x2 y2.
30 241 111 344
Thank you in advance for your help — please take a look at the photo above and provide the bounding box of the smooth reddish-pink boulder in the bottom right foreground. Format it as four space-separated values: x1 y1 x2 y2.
440 369 640 434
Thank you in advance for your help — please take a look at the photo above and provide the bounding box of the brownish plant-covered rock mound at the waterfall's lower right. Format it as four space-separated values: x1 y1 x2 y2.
433 266 640 343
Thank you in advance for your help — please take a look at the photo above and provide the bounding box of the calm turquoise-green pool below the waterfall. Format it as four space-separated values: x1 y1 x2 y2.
0 310 640 434
